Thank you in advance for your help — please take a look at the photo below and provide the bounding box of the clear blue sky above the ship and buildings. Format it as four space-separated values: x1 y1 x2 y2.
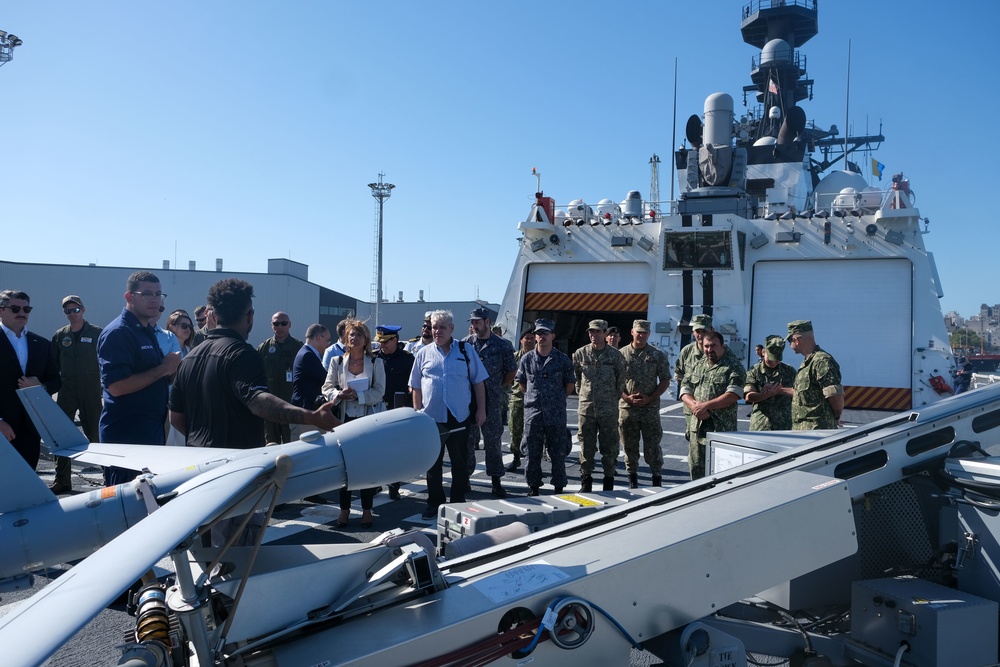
0 0 1000 315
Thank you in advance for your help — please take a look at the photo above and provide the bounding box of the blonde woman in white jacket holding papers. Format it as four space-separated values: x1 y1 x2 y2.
323 320 385 528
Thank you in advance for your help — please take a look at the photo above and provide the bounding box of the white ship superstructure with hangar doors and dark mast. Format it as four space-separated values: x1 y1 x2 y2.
498 0 954 410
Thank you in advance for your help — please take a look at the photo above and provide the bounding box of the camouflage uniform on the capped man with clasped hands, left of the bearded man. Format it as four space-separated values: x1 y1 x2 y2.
618 345 670 475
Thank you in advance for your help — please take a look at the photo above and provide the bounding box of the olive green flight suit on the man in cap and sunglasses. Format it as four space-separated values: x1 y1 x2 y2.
52 320 101 484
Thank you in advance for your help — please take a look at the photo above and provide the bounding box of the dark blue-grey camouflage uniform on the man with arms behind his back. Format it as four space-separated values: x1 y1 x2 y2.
514 348 575 489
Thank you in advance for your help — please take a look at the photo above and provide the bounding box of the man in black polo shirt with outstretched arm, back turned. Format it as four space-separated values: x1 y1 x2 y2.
170 278 340 449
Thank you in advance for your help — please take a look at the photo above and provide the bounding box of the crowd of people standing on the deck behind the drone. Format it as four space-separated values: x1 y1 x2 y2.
0 271 844 528
